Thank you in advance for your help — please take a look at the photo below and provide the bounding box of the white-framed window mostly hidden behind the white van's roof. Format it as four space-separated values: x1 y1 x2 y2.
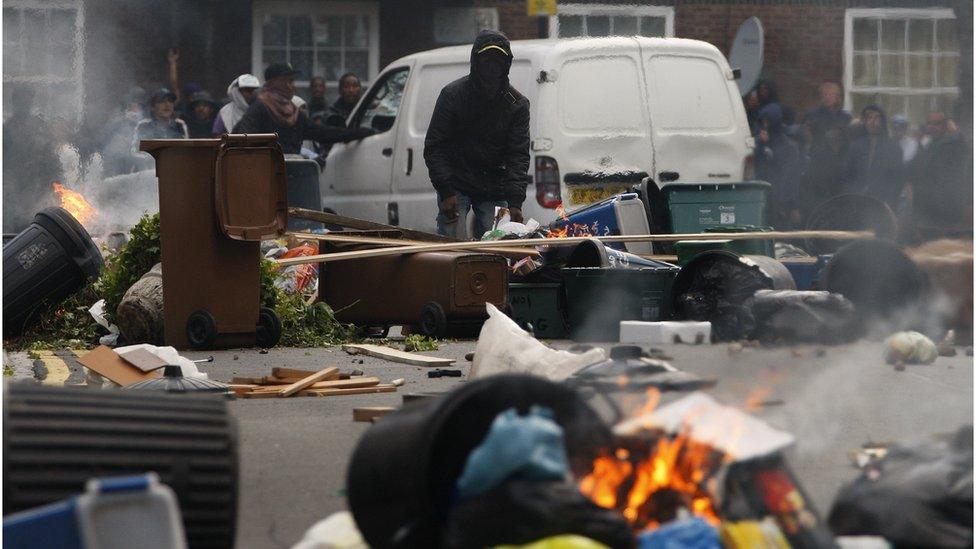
549 4 674 38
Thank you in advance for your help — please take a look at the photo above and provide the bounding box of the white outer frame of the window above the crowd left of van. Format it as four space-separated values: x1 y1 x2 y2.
250 0 380 87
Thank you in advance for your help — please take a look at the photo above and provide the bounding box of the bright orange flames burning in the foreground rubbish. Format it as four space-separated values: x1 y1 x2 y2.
579 389 724 530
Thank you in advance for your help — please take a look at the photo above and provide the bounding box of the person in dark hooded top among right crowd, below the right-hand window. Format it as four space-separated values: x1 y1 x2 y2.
844 105 905 210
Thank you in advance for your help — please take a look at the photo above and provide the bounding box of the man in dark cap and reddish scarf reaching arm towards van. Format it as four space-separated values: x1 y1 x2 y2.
233 63 376 154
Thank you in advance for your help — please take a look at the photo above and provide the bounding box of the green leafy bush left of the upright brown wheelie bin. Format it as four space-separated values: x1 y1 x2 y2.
96 214 162 316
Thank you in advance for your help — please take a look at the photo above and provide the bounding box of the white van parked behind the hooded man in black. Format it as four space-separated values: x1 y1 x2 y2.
320 37 753 231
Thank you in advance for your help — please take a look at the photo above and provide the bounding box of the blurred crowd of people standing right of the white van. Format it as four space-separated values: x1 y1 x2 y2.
743 80 973 241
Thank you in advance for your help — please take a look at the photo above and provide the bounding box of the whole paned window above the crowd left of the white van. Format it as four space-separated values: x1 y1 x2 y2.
252 1 379 95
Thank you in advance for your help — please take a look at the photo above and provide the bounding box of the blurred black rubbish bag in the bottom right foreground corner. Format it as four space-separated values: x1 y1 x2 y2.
828 425 973 547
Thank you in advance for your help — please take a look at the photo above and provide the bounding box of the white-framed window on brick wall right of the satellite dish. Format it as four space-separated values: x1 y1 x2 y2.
844 8 959 124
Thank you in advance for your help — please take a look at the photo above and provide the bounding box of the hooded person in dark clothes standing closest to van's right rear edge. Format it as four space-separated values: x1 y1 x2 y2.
756 103 800 229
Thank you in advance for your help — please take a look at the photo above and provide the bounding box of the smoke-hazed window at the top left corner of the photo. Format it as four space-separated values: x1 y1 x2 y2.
3 0 84 122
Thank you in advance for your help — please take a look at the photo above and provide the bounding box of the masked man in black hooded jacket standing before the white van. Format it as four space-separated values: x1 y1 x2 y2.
424 30 529 238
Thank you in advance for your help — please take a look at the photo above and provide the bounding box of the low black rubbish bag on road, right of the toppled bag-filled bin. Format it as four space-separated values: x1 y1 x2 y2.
746 290 855 344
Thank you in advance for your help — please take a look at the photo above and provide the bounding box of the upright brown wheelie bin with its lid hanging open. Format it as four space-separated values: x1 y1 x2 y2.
140 134 288 349
